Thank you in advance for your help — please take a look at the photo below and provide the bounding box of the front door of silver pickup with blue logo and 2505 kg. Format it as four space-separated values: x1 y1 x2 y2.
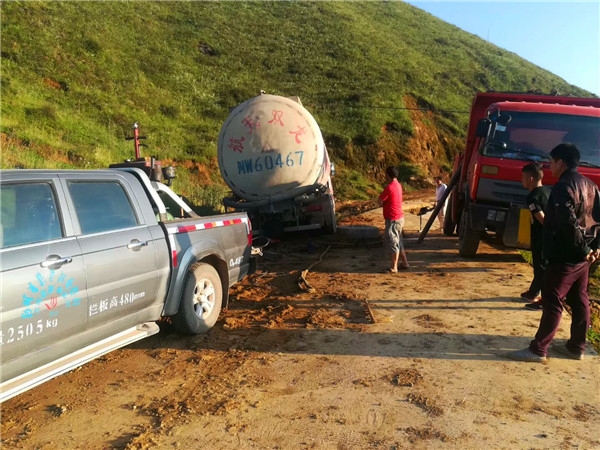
0 175 87 381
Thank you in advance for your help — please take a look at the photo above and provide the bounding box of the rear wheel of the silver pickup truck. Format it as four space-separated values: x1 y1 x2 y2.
173 263 223 334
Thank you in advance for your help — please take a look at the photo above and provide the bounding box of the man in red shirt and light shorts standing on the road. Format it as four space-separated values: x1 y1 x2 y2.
377 166 409 273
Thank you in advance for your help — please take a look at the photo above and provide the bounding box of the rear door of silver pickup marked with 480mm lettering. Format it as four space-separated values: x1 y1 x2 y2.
63 172 169 335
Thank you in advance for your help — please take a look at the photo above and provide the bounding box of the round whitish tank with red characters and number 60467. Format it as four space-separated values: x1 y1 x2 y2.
217 94 329 201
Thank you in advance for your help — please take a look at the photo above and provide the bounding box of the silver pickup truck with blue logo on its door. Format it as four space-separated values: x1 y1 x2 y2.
0 168 256 401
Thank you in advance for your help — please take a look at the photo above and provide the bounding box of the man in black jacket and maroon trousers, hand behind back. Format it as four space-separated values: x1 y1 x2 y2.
507 143 600 362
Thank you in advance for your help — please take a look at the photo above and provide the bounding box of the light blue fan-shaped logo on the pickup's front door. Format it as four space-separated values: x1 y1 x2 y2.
21 270 81 319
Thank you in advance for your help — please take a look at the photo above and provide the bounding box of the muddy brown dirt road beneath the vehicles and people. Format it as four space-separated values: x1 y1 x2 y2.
1 199 600 449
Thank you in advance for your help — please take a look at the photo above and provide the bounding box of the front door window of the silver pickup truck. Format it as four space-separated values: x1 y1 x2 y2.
0 183 63 248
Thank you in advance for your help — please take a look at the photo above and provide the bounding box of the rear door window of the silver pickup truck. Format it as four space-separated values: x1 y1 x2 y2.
69 181 139 234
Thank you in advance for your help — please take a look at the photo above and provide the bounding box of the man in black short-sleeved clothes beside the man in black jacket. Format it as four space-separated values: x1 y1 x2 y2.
521 163 550 310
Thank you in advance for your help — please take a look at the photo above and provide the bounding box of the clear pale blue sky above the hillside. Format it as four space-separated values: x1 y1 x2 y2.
406 0 600 96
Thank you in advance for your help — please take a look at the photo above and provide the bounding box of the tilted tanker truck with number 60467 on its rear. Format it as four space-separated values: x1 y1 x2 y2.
217 93 336 237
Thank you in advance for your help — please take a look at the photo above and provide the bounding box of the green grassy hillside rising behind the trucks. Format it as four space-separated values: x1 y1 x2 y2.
0 1 591 205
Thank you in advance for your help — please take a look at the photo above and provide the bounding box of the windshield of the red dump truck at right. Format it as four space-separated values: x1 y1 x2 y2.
481 111 600 167
